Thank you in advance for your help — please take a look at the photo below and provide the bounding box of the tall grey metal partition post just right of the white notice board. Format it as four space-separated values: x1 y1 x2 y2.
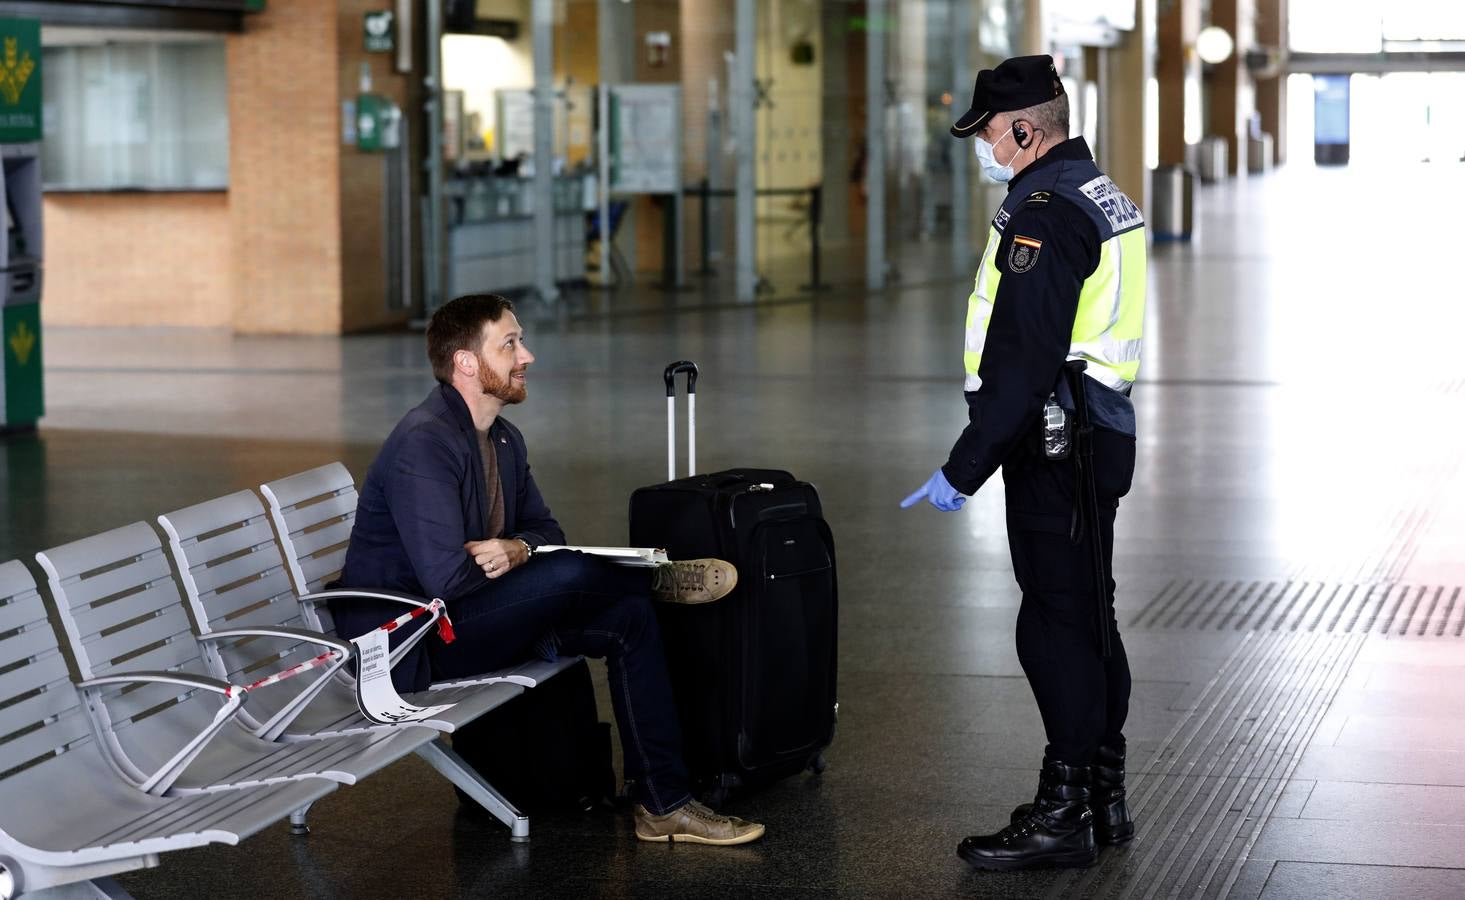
728 0 757 303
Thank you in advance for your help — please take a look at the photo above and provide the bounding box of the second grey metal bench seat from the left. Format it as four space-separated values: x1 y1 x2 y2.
35 522 437 796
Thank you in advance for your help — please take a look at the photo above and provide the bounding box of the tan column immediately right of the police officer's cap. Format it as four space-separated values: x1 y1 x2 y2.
1099 0 1154 214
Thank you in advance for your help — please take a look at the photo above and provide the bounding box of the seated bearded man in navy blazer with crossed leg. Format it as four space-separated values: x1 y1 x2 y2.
331 295 763 844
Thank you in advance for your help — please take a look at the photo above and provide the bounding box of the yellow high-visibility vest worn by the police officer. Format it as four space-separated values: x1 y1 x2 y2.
964 160 1149 394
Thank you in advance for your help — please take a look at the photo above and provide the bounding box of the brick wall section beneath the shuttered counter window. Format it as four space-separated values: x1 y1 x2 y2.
41 193 233 328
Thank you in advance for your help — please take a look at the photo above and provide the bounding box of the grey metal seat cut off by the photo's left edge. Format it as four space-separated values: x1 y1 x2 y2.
0 561 337 900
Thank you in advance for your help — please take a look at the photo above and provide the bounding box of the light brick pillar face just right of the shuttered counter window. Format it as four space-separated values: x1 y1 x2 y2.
229 0 342 334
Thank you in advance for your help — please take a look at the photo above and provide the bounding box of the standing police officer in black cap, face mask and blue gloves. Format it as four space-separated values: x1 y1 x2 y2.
901 56 1147 869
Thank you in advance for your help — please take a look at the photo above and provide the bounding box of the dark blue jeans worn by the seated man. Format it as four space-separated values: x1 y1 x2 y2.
429 551 691 814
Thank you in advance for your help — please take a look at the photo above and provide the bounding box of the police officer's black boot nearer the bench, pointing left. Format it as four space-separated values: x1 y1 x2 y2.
957 759 1099 871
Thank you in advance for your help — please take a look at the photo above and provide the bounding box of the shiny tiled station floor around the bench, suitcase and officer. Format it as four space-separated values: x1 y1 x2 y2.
0 166 1465 900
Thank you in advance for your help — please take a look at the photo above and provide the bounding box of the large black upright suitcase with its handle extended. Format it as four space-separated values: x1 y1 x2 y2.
630 362 838 802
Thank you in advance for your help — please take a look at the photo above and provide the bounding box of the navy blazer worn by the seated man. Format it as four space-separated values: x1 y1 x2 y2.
331 384 564 692
